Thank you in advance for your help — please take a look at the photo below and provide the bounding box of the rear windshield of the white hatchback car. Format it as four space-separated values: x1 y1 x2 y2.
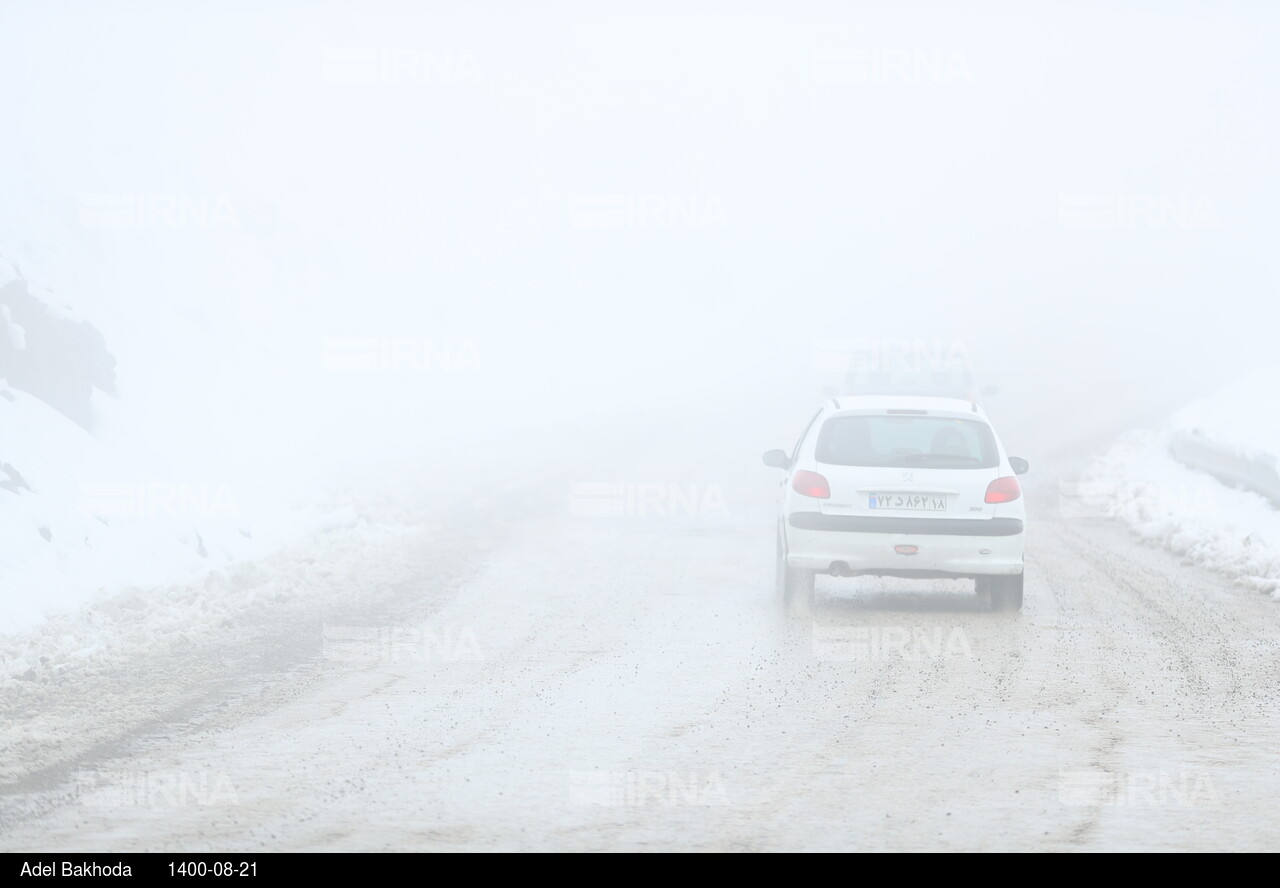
817 415 1000 468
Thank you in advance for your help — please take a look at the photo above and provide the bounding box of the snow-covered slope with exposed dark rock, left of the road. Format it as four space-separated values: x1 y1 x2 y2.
0 261 343 635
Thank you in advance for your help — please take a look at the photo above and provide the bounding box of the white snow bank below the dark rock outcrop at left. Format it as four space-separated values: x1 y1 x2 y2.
0 383 340 632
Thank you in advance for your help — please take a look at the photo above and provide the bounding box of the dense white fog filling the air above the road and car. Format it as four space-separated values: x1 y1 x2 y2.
3 4 1276 463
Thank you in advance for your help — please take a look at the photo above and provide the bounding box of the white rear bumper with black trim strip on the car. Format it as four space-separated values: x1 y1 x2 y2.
787 512 1024 577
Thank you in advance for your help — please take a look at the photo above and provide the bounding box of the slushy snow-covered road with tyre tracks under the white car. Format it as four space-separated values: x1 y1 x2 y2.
0 419 1280 851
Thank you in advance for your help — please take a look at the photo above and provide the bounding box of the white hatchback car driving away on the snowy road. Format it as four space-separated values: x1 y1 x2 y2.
764 395 1028 610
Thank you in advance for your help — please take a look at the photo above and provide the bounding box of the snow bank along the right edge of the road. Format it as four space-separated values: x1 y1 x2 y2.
1060 369 1280 599
